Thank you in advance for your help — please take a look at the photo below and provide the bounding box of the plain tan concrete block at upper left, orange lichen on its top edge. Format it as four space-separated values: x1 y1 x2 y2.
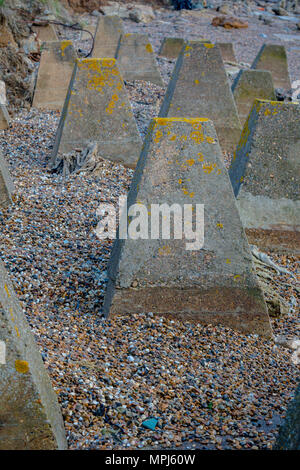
32 41 76 111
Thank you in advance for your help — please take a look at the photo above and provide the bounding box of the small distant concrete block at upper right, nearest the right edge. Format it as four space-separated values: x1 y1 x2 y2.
251 44 291 90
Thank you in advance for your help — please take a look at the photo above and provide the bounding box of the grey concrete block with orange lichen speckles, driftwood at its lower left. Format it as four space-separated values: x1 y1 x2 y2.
51 59 142 168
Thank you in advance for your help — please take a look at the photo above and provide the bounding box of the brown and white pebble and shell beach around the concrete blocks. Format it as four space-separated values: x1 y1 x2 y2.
0 4 300 450
